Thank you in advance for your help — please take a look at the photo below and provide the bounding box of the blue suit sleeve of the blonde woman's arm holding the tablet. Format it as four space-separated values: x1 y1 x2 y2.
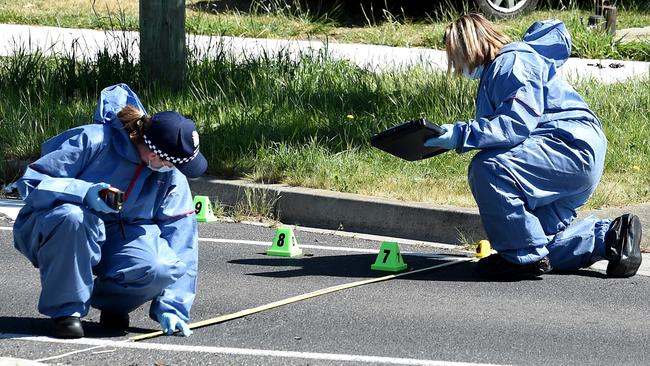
456 53 544 153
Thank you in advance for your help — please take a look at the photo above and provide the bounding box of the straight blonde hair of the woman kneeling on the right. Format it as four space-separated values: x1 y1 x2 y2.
444 13 512 75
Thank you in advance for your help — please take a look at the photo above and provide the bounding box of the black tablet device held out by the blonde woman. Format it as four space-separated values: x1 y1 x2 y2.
370 118 447 161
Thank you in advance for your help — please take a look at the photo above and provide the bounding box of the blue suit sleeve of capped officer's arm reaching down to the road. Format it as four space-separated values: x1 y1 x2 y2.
149 177 198 323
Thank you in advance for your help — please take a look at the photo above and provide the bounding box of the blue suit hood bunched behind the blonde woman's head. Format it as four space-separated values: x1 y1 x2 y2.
523 19 571 67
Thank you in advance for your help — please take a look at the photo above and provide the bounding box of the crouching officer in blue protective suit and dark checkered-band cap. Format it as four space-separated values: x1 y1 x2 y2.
14 84 207 338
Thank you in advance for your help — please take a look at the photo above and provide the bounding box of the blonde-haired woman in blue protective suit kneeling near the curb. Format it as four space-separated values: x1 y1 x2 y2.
425 14 641 279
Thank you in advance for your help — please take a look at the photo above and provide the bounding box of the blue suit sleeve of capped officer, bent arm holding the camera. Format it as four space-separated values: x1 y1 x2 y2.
17 129 103 209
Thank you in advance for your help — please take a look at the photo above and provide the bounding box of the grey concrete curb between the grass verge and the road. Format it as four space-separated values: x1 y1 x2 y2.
190 177 650 247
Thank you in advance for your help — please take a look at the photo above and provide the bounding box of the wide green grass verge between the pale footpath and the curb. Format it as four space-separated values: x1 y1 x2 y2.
0 41 650 207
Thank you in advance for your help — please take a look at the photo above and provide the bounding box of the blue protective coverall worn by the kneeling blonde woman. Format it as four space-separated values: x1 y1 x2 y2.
454 20 611 270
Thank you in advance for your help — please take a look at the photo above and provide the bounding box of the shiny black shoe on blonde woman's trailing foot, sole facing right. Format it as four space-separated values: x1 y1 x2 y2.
605 214 641 277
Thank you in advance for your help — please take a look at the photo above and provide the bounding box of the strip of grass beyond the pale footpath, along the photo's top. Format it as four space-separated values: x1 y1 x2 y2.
0 0 650 61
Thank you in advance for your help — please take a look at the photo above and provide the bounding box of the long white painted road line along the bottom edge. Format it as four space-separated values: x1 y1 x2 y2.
0 333 506 366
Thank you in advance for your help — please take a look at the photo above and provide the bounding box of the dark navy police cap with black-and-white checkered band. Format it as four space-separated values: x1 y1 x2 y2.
144 111 208 178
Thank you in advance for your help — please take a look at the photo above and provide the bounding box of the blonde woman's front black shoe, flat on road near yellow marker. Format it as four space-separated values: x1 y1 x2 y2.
476 254 552 280
